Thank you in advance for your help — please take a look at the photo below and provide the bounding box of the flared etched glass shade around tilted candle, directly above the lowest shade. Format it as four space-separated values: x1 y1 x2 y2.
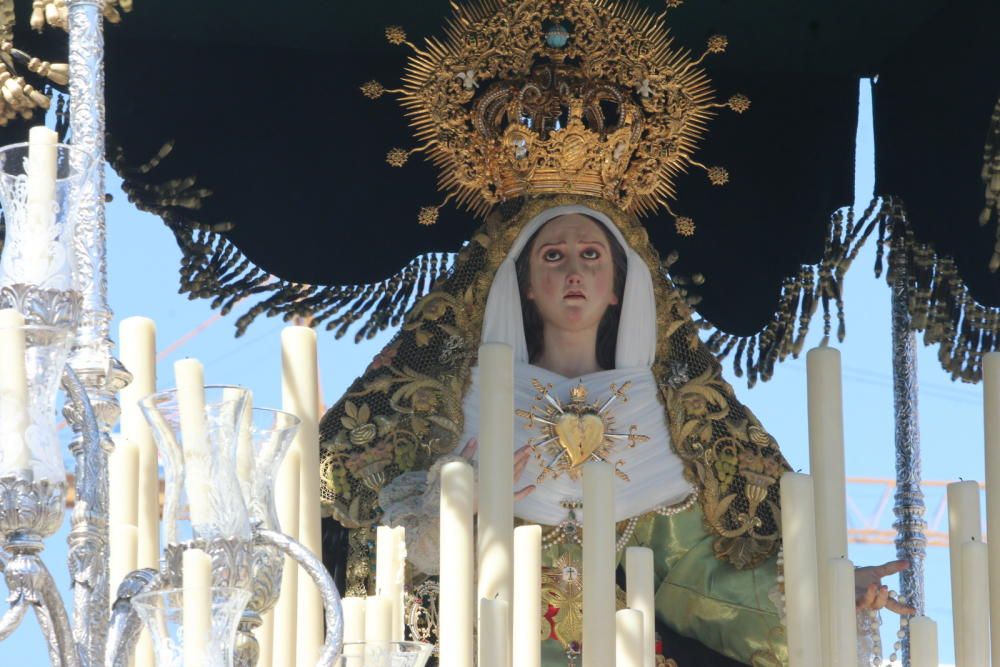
139 386 250 546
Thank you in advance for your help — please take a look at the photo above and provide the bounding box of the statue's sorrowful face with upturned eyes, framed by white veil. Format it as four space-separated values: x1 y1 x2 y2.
527 214 618 331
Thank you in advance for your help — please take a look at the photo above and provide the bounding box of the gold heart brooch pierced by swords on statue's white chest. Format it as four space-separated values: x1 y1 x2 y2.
517 380 649 483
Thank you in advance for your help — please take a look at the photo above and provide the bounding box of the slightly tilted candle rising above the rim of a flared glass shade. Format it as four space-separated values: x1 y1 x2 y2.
174 359 212 527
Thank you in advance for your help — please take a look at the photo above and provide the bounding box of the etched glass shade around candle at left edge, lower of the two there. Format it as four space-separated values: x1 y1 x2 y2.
0 325 73 484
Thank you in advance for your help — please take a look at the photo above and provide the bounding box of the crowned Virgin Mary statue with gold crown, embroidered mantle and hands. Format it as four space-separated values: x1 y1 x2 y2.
320 0 905 667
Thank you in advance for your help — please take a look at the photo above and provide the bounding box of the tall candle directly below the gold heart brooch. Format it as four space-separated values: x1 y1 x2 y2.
583 461 615 667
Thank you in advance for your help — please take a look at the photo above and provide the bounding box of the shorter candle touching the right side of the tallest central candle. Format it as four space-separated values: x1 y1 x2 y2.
511 526 542 667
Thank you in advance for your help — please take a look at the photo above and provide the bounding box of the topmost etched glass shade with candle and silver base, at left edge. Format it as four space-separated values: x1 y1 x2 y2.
0 143 93 328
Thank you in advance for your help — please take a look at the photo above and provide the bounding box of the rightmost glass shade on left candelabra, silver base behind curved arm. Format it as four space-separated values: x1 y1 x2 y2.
237 408 301 614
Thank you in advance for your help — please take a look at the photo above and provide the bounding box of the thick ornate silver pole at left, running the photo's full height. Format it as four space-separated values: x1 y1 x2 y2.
65 0 131 667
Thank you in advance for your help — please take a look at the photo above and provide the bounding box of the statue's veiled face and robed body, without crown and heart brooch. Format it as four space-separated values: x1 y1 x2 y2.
322 195 787 665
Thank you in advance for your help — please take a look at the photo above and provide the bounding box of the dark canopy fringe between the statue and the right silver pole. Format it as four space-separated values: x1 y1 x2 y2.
701 198 881 387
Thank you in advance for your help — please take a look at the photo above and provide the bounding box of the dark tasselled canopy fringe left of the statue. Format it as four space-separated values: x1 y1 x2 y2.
110 142 454 342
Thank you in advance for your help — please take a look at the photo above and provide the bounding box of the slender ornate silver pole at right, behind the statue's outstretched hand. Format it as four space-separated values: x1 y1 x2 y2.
889 235 927 667
